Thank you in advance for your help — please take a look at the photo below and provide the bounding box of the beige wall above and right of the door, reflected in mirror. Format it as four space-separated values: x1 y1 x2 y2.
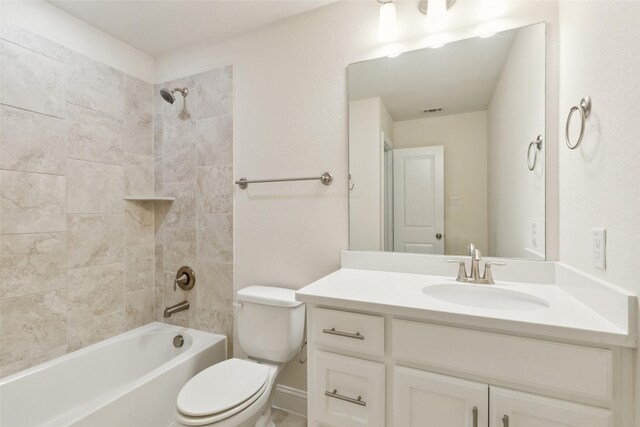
394 111 488 255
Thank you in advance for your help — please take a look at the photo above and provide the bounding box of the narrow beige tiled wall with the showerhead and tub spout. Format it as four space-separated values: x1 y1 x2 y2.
154 66 233 350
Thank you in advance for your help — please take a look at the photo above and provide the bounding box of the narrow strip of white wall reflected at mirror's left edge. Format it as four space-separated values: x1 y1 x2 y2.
349 98 384 251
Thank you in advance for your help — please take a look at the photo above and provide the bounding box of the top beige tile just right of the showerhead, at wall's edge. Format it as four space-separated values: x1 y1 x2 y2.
196 66 233 120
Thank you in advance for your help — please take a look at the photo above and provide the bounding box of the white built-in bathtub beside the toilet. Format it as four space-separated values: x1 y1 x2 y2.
0 323 226 427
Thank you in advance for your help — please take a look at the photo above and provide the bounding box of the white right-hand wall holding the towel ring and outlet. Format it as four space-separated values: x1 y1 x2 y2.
560 1 640 426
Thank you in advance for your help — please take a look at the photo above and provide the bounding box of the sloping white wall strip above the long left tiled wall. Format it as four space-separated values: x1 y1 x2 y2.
0 0 154 83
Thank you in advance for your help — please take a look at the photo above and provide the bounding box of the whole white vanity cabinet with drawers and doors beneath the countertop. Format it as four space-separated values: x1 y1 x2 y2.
308 306 632 427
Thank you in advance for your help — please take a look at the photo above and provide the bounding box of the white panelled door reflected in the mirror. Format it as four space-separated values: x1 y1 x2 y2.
393 145 444 254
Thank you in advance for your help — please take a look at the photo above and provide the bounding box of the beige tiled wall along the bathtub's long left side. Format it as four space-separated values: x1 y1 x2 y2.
0 25 156 376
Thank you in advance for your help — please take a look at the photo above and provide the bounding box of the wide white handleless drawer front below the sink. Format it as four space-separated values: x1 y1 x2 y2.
392 319 613 402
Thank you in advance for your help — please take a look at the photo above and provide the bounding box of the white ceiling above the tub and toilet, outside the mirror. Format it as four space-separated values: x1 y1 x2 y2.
48 0 335 56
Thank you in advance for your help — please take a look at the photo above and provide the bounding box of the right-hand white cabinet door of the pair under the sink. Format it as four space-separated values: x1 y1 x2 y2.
489 387 613 427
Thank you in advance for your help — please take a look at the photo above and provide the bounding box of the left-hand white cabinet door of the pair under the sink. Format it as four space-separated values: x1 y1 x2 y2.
393 366 489 427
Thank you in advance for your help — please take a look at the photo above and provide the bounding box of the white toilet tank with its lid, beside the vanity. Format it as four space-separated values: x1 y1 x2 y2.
236 286 305 363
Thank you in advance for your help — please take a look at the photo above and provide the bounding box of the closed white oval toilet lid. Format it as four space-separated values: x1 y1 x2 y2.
177 358 269 417
